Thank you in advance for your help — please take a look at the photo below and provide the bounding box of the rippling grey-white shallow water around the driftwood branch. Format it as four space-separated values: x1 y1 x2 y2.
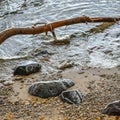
0 0 120 69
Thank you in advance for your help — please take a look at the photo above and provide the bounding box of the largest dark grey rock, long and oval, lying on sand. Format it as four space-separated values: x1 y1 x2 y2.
28 79 74 98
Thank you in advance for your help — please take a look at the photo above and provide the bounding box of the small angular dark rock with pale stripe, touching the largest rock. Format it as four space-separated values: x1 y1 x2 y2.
60 90 83 104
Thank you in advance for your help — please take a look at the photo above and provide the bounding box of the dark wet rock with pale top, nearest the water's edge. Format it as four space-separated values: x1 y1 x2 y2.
14 61 41 75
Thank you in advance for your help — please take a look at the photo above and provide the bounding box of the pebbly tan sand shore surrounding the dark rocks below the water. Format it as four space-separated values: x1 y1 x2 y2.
0 67 120 120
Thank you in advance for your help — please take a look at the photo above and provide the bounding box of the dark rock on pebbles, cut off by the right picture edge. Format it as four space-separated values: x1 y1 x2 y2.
102 100 120 116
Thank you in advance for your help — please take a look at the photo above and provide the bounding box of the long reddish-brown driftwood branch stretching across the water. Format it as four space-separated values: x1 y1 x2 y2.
0 16 120 44
